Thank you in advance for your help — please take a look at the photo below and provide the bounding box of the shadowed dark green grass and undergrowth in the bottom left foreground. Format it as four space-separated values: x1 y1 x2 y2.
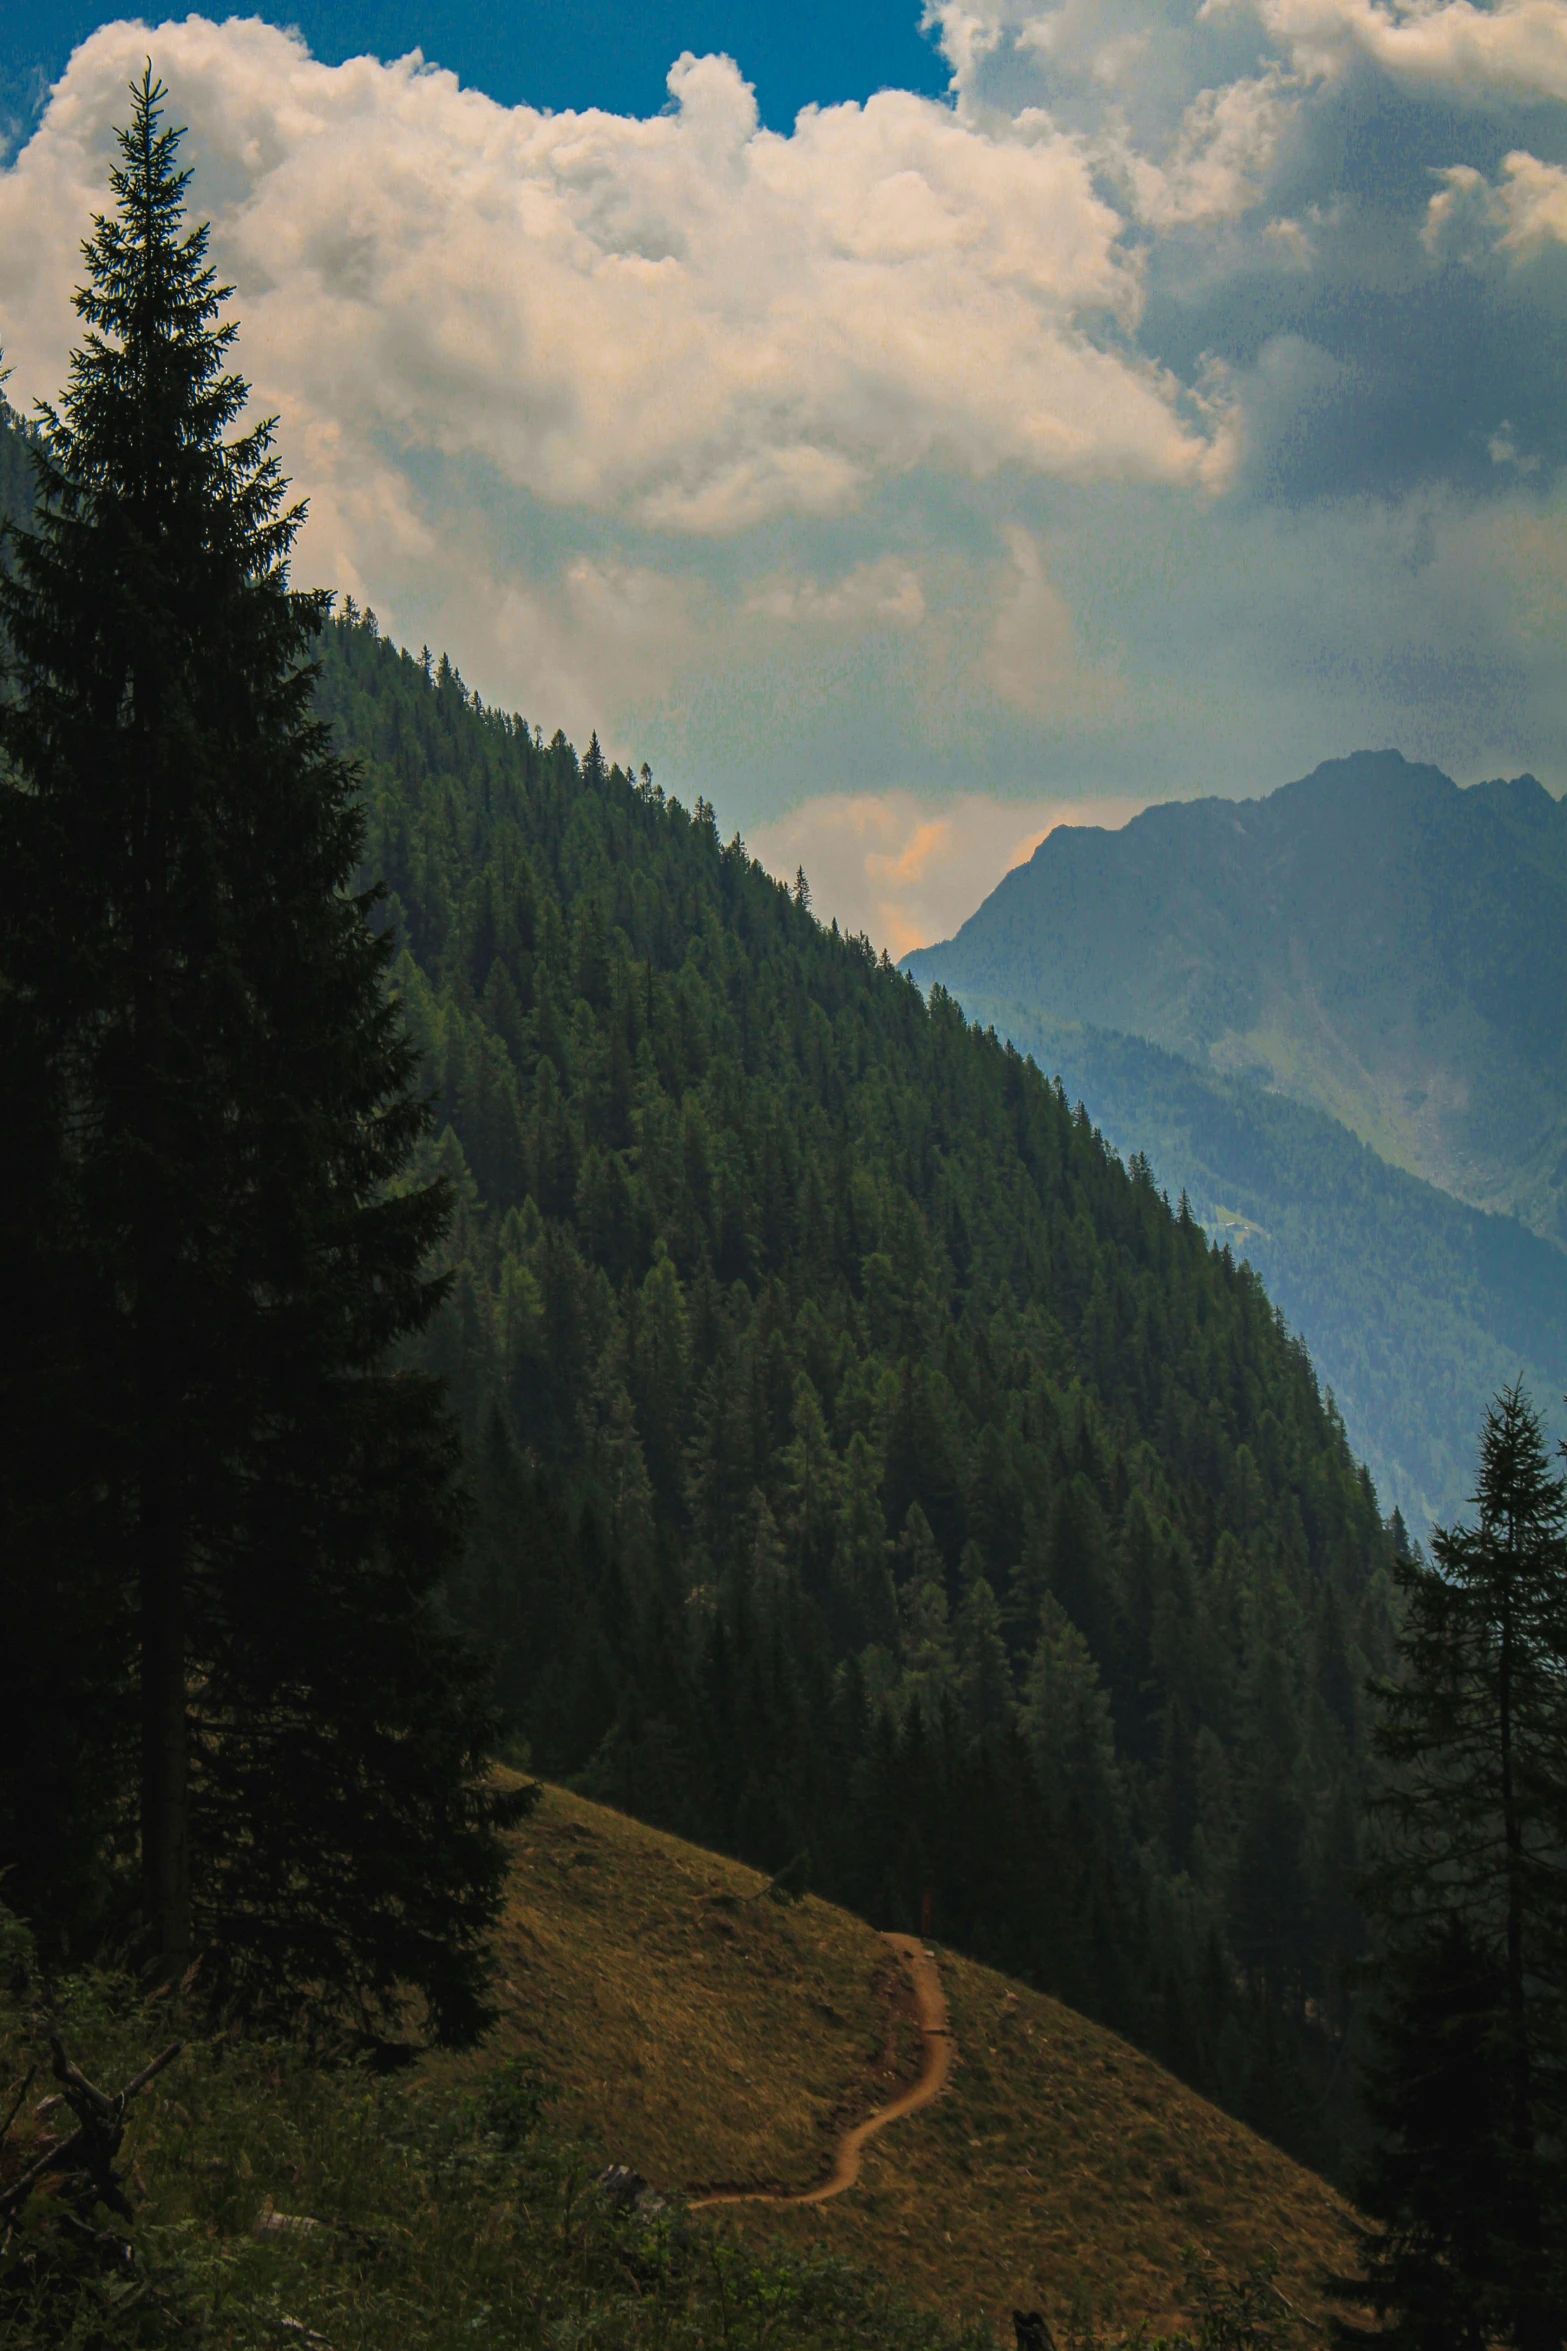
0 1980 977 2351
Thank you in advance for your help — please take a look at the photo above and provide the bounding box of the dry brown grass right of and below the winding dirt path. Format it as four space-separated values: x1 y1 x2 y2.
738 1951 1351 2337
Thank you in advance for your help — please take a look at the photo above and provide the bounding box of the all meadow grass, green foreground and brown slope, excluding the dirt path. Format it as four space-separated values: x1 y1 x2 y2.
0 1789 1351 2351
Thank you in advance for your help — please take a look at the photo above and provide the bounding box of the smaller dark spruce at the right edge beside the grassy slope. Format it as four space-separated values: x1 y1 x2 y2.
1358 1389 1567 2351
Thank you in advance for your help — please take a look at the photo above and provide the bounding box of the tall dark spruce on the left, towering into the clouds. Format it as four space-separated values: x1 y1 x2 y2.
0 66 512 2031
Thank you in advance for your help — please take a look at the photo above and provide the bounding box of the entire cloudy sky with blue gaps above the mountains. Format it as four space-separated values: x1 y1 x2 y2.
0 0 1567 952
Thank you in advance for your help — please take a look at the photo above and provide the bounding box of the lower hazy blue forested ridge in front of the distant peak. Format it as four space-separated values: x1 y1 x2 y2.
966 997 1567 1538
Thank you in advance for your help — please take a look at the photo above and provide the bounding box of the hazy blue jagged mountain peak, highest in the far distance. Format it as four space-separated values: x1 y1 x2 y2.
907 752 1567 1244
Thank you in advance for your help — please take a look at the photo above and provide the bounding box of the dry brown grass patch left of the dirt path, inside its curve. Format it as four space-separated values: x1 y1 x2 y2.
434 1789 919 2193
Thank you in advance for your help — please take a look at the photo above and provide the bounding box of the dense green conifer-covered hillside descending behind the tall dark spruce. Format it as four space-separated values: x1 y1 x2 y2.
310 614 1391 2156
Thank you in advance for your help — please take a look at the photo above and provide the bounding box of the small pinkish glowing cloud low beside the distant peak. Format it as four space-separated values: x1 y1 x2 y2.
749 792 1146 959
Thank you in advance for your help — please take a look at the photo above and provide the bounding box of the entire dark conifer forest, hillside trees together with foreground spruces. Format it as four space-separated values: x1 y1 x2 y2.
0 66 1567 2351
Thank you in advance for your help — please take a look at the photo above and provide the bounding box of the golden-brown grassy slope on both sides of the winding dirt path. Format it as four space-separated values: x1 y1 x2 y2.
444 1789 1349 2327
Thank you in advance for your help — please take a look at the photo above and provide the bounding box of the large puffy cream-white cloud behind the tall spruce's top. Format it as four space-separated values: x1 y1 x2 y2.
0 16 1212 554
